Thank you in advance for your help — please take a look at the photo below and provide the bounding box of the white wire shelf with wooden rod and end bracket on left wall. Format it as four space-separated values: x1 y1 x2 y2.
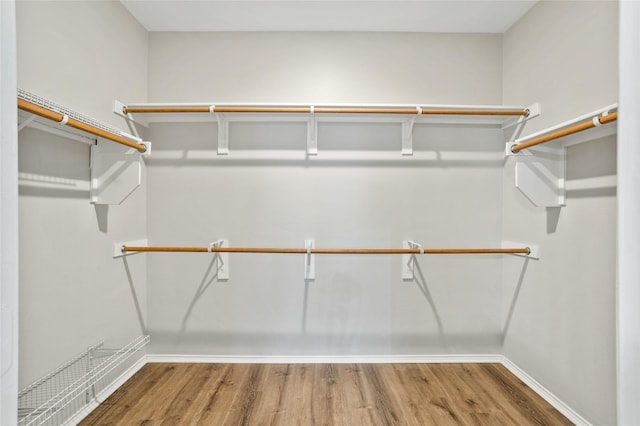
17 89 151 204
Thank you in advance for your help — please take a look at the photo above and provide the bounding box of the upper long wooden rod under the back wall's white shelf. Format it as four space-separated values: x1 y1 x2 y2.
122 106 529 116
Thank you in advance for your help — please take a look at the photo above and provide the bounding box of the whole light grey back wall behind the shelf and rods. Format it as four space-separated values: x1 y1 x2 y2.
147 33 510 355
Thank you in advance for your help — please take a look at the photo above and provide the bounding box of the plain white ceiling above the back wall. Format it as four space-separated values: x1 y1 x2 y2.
121 0 537 33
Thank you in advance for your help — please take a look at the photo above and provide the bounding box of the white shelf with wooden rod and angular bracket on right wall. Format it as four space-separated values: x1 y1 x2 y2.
505 104 618 207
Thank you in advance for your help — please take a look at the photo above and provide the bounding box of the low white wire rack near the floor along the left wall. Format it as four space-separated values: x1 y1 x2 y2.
18 336 149 426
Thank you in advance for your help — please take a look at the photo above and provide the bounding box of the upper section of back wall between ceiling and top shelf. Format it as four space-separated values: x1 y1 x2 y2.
149 32 502 105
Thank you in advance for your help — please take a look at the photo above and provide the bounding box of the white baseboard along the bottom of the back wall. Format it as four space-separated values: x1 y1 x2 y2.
147 355 502 364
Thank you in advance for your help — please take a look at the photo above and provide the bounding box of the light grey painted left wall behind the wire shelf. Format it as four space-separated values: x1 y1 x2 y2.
16 1 147 387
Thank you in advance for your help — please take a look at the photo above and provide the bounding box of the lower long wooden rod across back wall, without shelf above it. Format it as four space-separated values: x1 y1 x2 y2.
122 246 531 254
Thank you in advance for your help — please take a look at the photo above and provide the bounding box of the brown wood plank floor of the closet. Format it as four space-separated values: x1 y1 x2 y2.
80 364 572 426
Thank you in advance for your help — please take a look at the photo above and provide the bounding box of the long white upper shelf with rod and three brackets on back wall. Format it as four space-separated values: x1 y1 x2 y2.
114 101 540 155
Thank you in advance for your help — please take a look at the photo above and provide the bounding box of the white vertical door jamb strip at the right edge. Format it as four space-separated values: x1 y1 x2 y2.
617 2 640 425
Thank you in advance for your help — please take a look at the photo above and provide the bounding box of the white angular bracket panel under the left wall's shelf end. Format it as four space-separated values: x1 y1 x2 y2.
90 138 144 205
